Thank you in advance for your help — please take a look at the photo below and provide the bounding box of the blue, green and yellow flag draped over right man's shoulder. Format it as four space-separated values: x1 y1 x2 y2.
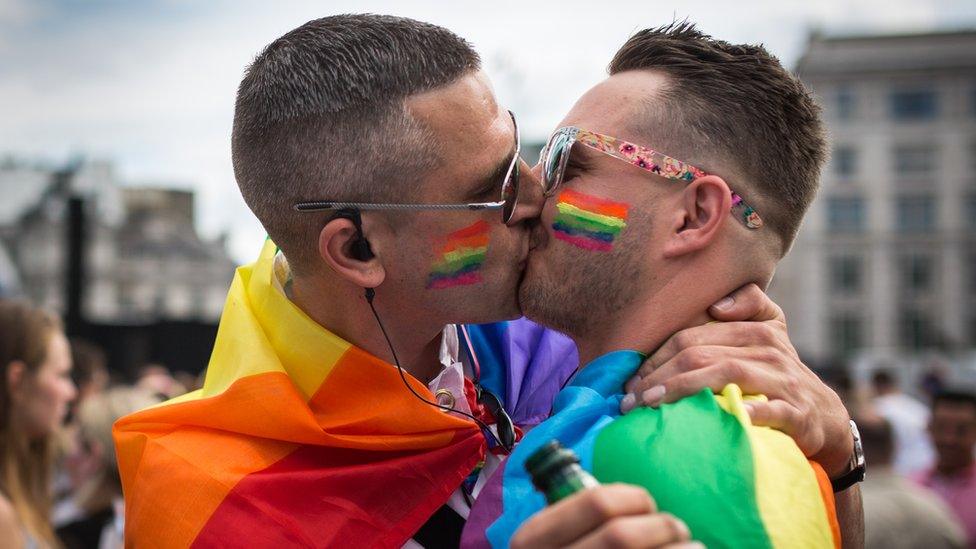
472 351 840 548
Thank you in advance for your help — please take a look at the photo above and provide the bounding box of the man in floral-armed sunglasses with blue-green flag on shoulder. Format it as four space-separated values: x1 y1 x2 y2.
465 23 864 547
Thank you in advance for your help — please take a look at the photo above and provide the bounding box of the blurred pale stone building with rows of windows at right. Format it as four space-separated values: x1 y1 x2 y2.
770 31 976 360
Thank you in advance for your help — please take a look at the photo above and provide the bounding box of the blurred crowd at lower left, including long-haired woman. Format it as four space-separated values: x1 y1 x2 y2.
0 299 198 549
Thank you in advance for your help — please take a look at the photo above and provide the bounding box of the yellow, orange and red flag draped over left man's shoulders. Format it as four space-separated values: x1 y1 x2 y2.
114 241 485 548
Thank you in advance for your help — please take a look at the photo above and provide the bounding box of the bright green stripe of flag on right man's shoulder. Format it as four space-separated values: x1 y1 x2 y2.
593 389 772 548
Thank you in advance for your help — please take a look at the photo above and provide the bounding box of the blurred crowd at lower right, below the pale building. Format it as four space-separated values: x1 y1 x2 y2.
829 367 976 548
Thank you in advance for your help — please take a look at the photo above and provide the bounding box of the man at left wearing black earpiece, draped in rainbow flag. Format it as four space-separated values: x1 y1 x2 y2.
116 15 860 547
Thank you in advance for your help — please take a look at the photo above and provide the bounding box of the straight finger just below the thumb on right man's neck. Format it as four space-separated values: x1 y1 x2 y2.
638 322 796 376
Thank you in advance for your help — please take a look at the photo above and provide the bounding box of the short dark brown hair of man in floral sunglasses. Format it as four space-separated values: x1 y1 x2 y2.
608 22 827 254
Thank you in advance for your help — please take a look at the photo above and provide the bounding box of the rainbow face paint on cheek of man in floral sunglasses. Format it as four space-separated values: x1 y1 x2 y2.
552 189 628 252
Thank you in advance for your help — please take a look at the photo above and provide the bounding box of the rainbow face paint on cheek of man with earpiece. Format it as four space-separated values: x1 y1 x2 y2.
427 221 489 290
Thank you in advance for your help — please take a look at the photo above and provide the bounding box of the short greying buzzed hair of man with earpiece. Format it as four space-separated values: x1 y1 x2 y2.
231 15 481 273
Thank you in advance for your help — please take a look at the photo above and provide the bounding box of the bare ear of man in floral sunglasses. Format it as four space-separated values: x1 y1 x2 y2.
664 175 732 258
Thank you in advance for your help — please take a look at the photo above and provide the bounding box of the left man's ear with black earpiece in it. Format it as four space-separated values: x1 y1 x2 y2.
318 217 386 288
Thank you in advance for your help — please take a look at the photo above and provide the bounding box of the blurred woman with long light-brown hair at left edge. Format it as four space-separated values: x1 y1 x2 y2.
0 300 77 548
